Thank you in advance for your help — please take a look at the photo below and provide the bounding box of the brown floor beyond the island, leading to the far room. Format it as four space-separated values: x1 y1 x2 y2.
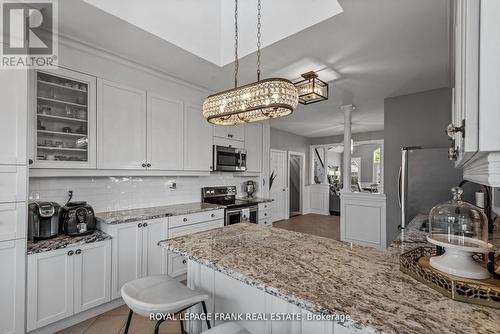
273 213 340 240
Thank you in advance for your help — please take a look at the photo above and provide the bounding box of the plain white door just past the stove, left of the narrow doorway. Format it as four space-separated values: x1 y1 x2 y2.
270 150 288 221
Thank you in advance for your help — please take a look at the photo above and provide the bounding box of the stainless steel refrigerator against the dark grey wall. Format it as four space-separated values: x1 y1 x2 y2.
398 146 462 228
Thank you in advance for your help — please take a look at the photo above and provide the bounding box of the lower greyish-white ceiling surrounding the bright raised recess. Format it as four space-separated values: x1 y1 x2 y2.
59 0 449 137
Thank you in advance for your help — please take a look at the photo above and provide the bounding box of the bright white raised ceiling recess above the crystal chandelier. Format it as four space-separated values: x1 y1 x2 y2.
84 0 342 66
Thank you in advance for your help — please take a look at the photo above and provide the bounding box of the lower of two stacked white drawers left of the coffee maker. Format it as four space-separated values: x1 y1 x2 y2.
0 203 26 241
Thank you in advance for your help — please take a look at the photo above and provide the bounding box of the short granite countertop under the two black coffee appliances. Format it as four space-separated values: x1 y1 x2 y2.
27 230 111 255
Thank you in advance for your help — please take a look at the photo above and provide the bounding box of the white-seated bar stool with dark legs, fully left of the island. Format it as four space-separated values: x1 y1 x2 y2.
121 275 211 334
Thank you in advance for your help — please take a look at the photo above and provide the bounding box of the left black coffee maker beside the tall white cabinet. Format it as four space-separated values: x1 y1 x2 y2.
28 202 61 241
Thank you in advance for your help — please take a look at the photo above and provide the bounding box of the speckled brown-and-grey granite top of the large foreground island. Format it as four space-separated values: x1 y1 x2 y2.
160 219 500 334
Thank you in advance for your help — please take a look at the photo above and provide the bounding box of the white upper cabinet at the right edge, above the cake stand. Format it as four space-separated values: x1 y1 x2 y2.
449 0 500 186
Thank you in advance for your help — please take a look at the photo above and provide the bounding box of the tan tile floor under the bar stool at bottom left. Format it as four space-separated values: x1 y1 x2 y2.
57 305 181 334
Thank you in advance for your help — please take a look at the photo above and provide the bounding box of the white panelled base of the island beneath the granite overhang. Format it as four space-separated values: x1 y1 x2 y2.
187 260 366 334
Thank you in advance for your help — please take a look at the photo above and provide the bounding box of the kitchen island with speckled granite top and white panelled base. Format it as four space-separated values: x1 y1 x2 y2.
160 223 500 334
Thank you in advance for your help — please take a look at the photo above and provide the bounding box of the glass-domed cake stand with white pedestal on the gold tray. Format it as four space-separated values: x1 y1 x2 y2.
427 187 493 279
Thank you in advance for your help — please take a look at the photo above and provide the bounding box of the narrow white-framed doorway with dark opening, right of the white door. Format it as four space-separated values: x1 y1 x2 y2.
288 151 305 217
